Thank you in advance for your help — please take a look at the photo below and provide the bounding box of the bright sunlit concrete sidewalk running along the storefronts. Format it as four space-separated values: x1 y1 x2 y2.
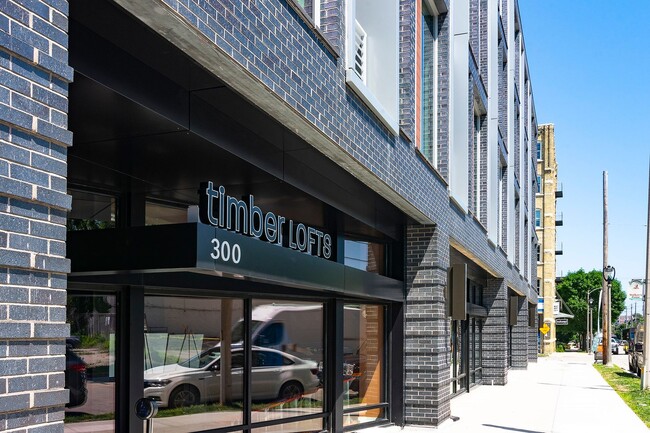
373 352 650 433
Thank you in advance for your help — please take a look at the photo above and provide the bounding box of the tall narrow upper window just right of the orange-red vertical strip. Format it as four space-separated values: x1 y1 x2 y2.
420 0 438 167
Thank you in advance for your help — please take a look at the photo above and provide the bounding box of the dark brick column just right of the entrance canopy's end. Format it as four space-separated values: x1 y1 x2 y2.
404 226 450 426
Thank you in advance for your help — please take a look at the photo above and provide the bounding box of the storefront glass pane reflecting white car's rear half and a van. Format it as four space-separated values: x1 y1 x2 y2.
248 299 324 424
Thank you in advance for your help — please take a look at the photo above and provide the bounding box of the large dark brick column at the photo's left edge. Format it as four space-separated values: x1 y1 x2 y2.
0 0 72 432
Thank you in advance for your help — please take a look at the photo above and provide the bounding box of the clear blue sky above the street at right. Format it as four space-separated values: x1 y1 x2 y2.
519 0 650 313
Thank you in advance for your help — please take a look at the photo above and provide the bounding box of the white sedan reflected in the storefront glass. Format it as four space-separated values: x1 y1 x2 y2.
144 346 319 408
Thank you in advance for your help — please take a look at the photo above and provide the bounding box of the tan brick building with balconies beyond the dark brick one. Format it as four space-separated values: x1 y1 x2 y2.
535 124 563 353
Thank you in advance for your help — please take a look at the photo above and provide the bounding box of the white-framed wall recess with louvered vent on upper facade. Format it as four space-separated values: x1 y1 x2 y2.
344 0 399 135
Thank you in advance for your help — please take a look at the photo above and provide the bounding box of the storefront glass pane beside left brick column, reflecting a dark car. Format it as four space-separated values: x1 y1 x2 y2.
64 292 117 432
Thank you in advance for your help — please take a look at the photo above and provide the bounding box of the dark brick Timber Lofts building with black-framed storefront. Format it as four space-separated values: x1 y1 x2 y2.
0 0 538 432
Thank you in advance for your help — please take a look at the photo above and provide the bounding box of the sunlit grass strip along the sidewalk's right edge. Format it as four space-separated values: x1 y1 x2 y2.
594 364 650 427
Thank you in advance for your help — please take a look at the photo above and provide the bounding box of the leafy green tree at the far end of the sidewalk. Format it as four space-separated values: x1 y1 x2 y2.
556 269 625 342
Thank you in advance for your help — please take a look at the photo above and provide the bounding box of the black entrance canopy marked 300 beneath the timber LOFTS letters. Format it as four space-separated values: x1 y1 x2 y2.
68 223 404 302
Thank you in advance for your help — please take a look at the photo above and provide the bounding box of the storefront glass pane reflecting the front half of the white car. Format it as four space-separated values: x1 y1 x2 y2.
144 296 244 433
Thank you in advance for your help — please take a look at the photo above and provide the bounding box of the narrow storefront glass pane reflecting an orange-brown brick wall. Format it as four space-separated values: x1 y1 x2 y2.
343 304 386 426
